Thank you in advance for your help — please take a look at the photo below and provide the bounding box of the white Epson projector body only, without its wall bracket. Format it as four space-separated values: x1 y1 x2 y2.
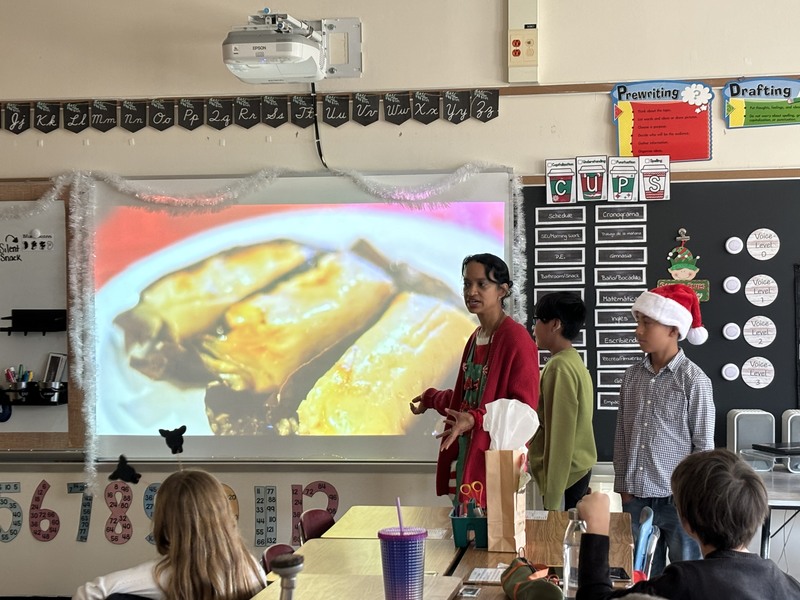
222 28 325 83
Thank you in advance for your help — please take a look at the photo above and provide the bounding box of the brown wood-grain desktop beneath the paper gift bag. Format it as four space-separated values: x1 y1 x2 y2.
453 511 633 600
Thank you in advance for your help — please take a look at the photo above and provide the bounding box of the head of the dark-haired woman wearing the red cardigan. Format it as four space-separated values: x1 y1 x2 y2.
461 254 514 314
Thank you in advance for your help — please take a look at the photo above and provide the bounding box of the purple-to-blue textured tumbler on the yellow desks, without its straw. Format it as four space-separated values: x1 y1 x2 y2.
378 527 428 600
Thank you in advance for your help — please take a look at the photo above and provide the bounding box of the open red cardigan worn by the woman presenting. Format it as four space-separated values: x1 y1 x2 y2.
422 317 539 501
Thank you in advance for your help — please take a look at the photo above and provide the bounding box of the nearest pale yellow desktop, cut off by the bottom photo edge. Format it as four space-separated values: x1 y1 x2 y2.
252 572 461 600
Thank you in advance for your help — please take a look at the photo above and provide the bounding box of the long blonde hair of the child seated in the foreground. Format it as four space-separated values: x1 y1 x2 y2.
153 470 266 600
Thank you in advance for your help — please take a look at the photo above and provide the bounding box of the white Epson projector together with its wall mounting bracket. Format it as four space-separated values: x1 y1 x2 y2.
222 9 361 83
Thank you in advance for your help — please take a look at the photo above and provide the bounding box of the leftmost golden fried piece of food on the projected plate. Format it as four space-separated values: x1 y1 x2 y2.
114 240 315 366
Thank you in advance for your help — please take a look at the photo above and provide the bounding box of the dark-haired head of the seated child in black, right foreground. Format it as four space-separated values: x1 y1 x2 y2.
672 448 768 550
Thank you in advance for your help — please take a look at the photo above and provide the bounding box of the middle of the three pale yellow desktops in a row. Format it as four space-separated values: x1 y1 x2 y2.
267 538 463 581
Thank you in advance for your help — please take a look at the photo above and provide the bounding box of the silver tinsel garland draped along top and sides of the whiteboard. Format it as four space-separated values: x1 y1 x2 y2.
0 163 527 493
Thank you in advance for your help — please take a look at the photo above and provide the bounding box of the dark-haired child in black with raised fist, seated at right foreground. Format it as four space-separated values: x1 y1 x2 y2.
577 448 800 600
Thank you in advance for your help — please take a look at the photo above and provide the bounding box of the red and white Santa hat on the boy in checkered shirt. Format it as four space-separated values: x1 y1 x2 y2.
631 283 708 345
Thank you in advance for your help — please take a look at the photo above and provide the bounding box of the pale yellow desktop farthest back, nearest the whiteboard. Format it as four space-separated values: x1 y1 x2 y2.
322 506 453 540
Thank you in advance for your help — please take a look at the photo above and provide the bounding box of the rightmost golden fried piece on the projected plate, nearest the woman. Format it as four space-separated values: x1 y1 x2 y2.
297 292 475 435
